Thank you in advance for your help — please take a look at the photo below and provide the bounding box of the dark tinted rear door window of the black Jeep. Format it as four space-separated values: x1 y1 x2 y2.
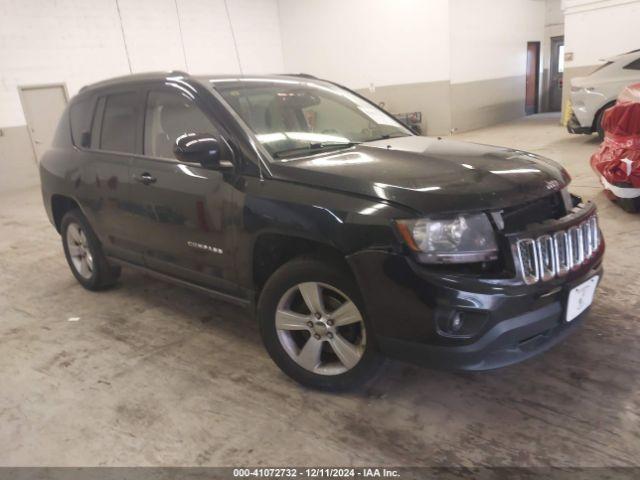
100 92 138 153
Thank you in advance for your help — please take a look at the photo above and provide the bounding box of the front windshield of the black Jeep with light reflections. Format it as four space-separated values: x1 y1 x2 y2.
214 79 412 158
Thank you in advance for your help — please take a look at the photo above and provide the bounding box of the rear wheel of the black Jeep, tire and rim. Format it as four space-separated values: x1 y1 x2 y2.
60 209 120 291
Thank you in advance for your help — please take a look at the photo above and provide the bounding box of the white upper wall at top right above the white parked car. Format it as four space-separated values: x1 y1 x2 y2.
563 0 640 68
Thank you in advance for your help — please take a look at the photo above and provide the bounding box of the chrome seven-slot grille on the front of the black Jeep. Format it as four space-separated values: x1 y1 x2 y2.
516 215 600 284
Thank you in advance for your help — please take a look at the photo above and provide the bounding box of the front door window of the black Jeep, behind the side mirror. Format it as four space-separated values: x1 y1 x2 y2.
144 91 218 159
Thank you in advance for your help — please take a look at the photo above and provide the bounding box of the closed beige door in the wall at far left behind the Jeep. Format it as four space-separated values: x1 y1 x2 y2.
18 84 69 162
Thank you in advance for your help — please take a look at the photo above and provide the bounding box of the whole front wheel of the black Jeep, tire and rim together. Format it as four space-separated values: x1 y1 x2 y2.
257 257 383 391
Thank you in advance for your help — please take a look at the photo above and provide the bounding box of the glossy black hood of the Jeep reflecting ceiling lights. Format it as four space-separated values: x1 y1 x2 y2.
272 136 570 214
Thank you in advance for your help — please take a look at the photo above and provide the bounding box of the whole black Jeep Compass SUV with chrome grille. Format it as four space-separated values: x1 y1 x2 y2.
40 72 604 389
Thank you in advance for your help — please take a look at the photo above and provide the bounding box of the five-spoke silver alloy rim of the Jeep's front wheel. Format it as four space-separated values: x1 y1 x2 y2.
276 282 367 375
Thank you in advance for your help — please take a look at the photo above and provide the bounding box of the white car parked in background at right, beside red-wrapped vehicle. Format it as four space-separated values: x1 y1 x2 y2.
567 50 640 138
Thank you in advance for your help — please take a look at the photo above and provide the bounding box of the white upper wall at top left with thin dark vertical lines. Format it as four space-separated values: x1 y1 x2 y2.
0 0 283 127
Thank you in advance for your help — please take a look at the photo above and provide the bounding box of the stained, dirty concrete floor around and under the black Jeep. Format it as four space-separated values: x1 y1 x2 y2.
0 112 640 466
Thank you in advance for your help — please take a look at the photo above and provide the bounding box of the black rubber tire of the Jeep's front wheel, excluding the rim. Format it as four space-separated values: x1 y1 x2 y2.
257 258 382 391
